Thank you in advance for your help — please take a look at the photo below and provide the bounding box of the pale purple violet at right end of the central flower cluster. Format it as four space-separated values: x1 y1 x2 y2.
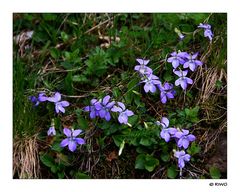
111 102 134 124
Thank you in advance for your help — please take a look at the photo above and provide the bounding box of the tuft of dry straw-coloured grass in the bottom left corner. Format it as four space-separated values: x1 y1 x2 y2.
13 135 41 179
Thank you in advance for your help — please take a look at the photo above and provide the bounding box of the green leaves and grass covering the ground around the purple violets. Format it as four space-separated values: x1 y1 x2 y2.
13 13 227 179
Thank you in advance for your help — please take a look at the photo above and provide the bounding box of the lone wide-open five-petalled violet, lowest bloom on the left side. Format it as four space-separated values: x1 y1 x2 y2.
60 128 85 152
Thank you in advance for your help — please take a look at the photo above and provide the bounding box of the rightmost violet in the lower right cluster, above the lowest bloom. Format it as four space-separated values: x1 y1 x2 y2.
174 129 196 149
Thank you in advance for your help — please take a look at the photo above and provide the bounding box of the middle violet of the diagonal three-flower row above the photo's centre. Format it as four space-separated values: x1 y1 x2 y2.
141 74 161 93
